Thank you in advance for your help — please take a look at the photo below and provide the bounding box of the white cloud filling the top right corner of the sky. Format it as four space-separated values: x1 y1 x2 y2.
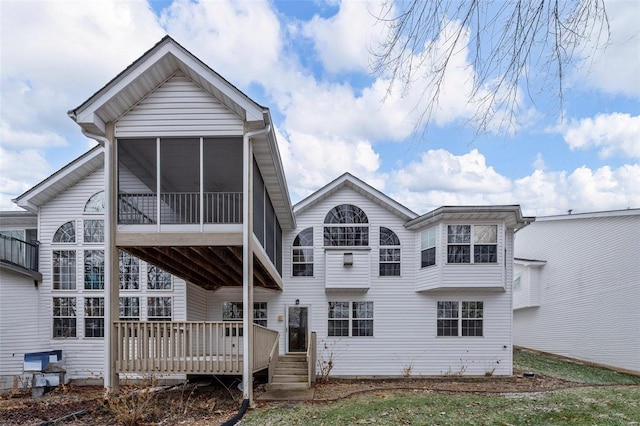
577 0 640 99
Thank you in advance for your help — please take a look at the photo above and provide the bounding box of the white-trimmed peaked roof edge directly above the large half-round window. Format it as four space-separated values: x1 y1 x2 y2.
293 173 418 221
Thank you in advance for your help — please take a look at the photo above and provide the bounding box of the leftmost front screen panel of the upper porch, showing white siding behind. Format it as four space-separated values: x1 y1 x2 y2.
117 138 158 224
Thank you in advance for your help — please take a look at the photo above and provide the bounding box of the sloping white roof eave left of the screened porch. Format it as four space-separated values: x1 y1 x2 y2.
12 145 104 213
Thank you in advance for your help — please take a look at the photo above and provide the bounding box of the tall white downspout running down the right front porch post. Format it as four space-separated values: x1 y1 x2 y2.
242 124 271 406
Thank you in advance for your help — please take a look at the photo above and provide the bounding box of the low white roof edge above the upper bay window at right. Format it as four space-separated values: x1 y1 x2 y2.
404 205 536 230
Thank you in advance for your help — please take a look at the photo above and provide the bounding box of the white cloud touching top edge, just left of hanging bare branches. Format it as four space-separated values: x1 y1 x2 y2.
302 0 386 73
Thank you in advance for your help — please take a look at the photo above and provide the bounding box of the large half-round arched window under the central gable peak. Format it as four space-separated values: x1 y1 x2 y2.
324 204 369 247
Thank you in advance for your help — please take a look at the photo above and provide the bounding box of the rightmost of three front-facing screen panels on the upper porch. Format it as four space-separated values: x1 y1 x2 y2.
203 138 242 223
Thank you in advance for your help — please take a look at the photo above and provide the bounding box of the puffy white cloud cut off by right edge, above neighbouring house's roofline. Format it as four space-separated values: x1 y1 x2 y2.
559 113 640 158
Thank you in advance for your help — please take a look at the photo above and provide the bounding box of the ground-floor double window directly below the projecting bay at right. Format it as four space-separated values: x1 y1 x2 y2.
437 301 484 337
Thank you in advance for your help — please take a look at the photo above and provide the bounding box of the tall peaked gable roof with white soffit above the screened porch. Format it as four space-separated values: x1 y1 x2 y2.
67 36 266 136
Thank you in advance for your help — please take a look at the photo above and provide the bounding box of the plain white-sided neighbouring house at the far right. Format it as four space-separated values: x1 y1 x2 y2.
513 209 640 374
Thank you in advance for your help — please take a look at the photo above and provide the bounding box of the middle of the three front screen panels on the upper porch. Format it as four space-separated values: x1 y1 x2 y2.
160 138 200 224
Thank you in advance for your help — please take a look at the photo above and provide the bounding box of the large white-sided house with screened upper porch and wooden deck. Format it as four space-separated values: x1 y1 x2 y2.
0 37 533 399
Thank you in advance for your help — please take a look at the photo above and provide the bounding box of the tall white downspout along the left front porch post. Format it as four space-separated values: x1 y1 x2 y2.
81 129 118 389
